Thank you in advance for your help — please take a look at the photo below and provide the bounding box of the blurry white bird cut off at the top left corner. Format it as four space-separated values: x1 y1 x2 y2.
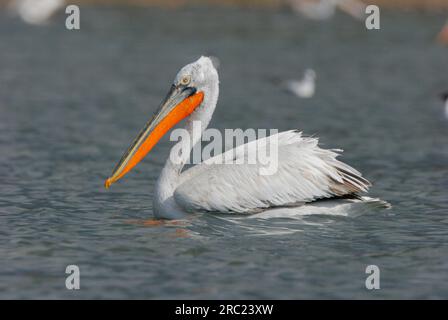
10 0 65 25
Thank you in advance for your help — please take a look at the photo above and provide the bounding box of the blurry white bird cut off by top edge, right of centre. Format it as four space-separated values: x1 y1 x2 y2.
288 0 366 20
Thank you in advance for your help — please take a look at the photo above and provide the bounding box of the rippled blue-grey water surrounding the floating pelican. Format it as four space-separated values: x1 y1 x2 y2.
0 7 448 299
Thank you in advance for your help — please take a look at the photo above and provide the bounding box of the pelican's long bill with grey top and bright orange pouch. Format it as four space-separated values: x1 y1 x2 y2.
104 86 204 188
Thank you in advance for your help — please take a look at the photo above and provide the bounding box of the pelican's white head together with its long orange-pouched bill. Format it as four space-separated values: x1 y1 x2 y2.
104 56 218 188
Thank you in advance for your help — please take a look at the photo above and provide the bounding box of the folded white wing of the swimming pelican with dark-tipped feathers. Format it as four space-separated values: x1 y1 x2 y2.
174 131 370 213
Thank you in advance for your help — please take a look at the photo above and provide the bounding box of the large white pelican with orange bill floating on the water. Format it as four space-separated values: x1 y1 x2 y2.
105 56 370 219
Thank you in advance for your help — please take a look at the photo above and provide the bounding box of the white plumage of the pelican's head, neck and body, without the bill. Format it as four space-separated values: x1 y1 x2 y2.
149 57 370 218
